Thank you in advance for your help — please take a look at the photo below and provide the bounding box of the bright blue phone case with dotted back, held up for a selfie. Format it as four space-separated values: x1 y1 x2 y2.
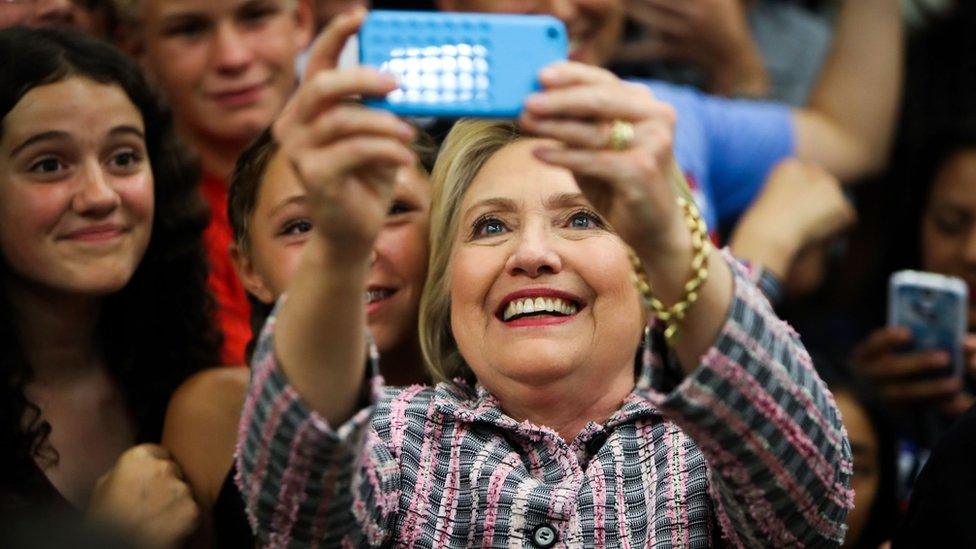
359 10 569 118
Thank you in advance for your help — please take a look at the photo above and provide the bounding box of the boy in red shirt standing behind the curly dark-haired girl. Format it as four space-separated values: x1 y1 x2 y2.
117 0 313 364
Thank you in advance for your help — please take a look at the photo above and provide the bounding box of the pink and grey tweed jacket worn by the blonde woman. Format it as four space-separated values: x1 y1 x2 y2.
237 255 853 549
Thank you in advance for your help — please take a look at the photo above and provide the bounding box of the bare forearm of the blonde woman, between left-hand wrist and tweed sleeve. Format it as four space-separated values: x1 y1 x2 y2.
274 234 369 426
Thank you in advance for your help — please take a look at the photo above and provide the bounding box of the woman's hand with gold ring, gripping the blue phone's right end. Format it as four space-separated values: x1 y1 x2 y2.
519 62 690 267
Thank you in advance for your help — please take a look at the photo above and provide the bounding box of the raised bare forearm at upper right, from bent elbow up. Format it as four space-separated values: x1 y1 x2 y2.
795 0 904 181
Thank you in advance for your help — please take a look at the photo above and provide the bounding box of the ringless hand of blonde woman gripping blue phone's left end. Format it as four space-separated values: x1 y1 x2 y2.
272 10 415 262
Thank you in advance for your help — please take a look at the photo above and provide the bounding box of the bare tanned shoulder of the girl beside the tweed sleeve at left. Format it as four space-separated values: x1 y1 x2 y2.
162 366 250 503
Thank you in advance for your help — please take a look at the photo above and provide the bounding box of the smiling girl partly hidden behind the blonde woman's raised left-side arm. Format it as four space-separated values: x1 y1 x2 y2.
163 127 435 547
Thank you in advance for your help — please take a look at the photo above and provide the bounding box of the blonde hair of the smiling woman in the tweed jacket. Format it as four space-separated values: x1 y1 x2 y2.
419 120 692 383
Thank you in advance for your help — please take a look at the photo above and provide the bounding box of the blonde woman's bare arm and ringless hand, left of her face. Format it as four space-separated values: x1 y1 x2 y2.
273 11 414 425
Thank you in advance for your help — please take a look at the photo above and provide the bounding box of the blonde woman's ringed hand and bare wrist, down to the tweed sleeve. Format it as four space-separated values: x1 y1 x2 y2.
519 58 732 372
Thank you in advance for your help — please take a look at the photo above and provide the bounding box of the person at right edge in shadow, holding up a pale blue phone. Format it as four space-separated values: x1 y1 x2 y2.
851 124 976 504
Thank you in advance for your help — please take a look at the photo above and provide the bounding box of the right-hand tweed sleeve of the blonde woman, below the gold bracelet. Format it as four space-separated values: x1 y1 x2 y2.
648 254 853 547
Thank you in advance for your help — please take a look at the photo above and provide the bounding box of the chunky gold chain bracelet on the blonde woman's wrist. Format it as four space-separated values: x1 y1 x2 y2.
630 197 712 345
